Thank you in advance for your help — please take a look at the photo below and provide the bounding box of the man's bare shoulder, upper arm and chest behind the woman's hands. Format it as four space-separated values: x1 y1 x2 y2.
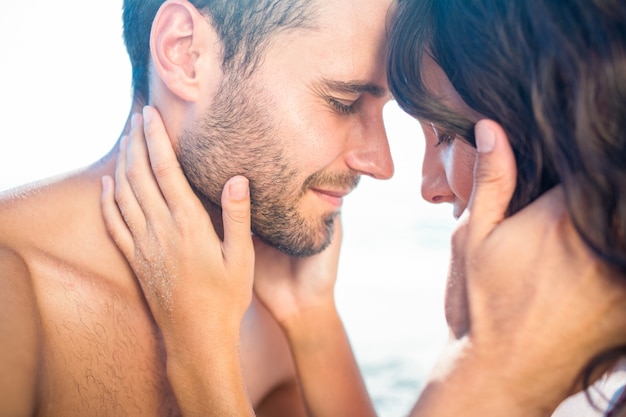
0 141 305 416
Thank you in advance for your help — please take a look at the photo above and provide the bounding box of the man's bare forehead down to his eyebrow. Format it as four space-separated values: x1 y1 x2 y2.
254 0 391 94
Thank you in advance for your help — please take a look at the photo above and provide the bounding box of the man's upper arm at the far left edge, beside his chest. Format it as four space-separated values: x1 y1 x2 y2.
0 247 40 416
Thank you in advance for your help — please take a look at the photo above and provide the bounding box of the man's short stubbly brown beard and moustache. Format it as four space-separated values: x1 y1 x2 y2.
178 75 359 257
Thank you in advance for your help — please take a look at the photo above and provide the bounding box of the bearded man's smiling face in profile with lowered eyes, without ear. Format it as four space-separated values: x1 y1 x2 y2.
179 0 393 256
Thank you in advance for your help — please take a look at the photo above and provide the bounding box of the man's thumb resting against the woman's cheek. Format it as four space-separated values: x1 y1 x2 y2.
468 119 517 240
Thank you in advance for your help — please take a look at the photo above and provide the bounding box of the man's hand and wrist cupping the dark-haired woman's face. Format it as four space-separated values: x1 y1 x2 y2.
412 121 626 417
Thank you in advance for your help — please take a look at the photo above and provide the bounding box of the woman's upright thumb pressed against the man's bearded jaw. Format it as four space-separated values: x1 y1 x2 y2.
217 176 254 264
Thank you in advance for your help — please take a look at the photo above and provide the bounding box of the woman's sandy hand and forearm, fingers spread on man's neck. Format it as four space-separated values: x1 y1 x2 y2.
102 108 254 417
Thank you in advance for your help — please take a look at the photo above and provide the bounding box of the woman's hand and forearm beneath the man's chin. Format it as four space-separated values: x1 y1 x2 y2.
254 228 376 417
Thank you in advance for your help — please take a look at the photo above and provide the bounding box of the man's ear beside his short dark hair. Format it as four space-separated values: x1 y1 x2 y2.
150 0 222 102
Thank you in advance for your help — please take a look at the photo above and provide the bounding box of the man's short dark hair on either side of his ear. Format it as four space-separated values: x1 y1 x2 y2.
123 0 314 103
